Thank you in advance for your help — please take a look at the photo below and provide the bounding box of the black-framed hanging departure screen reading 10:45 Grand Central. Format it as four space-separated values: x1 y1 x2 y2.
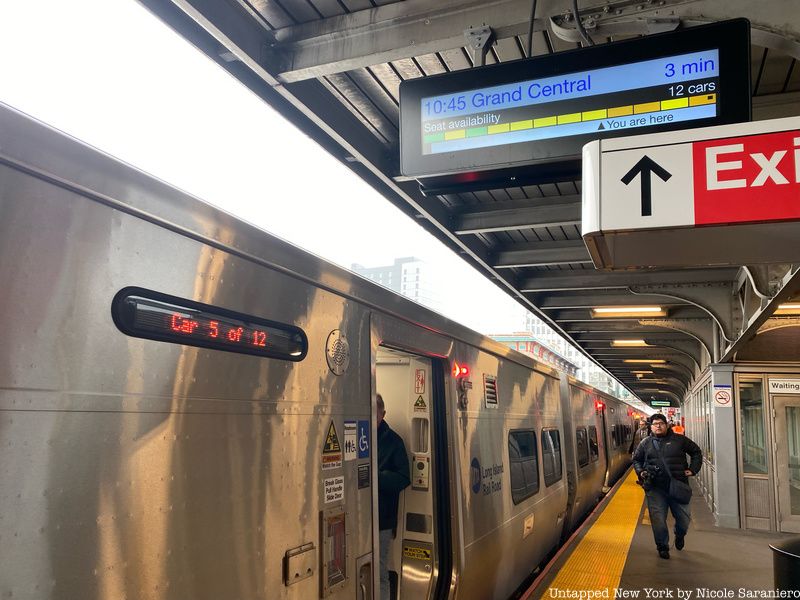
400 19 750 177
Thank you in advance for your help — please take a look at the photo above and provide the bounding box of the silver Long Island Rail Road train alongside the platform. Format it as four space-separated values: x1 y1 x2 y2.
0 106 633 600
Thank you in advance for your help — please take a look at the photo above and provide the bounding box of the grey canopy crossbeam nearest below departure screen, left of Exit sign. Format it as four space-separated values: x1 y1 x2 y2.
452 195 581 235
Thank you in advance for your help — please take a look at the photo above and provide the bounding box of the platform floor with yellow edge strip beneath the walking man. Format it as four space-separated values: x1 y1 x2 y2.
520 469 792 600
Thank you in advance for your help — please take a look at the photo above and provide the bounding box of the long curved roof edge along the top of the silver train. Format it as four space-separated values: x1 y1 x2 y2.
0 102 572 377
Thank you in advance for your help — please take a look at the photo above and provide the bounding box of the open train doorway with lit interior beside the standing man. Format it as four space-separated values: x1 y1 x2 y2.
375 347 450 600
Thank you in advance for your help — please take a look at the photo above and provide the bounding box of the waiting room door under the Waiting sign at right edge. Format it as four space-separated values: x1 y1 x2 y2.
773 395 800 533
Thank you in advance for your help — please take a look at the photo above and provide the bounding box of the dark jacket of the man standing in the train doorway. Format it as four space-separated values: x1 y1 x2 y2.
378 421 411 530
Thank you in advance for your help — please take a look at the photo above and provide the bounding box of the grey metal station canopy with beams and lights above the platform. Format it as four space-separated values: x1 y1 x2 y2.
140 0 800 406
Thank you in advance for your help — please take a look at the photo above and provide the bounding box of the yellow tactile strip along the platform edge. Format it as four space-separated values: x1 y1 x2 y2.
544 471 644 598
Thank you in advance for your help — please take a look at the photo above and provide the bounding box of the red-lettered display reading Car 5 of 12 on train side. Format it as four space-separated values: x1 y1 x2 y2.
111 288 308 361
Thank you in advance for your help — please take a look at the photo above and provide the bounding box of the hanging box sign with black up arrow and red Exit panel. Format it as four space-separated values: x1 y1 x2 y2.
582 117 800 268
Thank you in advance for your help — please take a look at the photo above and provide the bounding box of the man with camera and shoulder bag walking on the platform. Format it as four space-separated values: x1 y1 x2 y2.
633 414 703 558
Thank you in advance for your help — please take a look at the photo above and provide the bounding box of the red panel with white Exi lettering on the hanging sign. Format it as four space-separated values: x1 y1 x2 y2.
692 130 800 225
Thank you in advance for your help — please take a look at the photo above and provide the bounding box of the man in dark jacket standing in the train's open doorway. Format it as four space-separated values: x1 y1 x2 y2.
376 394 411 600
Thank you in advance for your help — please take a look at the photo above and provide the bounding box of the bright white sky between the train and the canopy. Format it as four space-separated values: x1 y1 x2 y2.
0 0 536 334
